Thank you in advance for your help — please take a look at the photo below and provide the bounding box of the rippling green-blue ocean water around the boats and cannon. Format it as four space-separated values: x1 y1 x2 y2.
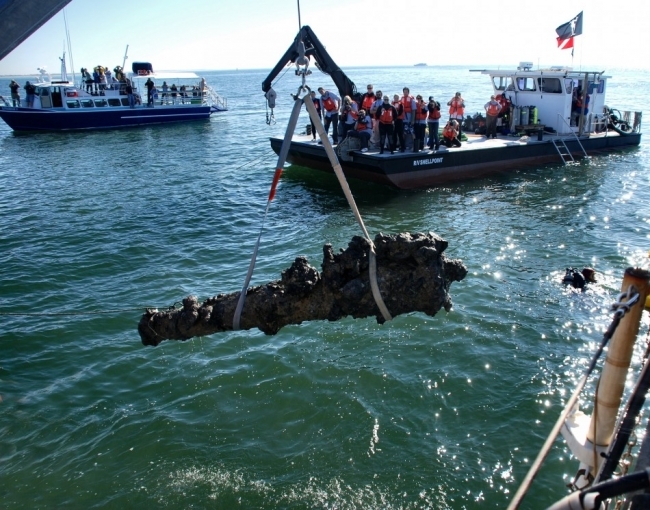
0 67 650 509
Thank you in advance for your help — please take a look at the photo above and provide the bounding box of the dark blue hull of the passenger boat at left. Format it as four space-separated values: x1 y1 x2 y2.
0 105 212 131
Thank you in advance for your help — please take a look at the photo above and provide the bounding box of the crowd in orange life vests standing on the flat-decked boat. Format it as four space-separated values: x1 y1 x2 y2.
310 84 510 154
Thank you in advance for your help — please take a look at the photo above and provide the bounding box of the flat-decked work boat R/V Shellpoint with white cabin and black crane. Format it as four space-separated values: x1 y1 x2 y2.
262 26 642 189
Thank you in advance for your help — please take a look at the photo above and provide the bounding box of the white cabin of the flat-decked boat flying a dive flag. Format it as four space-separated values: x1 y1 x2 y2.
480 62 609 136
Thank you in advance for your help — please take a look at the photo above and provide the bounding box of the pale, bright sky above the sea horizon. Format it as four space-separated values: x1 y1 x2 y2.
0 0 650 75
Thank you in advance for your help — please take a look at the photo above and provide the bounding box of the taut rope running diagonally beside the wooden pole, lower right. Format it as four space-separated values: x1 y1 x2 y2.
507 285 639 510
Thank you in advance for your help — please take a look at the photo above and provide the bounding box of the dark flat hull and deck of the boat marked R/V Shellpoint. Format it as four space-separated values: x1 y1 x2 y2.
271 130 641 189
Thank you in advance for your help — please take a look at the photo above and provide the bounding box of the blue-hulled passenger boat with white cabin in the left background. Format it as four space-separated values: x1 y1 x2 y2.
0 55 227 131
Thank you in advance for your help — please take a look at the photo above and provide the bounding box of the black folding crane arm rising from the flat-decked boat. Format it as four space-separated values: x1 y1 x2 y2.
262 25 359 99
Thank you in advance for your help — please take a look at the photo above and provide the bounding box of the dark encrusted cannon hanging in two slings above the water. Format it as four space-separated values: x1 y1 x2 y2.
138 232 467 346
